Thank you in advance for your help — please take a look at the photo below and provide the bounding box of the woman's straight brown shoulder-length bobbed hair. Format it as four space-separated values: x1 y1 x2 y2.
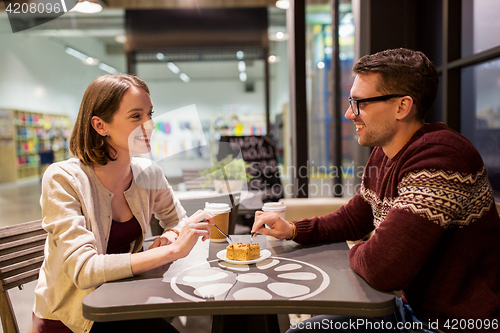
69 74 149 165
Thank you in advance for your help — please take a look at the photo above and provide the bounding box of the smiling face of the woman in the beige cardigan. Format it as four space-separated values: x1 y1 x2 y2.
105 86 155 158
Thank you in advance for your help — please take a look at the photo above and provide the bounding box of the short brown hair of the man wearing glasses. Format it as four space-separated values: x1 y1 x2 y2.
352 48 439 120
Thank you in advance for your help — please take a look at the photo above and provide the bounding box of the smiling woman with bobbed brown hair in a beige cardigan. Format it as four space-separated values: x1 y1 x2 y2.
30 74 213 333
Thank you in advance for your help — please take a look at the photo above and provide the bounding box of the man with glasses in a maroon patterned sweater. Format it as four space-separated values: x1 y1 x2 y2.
252 49 500 332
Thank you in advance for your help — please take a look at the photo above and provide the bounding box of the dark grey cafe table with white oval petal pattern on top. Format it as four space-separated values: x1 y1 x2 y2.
83 235 395 333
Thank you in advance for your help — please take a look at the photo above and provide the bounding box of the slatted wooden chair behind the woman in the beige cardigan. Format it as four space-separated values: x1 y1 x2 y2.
0 220 47 333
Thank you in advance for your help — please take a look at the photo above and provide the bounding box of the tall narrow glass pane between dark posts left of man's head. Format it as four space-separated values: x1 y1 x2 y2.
306 1 357 197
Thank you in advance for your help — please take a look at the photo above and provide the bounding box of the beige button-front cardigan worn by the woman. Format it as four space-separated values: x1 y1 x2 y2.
33 158 186 333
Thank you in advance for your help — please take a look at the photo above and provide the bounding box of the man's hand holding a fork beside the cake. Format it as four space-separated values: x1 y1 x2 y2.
251 211 293 239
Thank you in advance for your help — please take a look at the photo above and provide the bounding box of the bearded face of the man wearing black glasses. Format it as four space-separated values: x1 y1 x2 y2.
344 73 400 148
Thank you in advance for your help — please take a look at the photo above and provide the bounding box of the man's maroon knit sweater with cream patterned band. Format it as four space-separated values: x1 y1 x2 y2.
295 123 500 332
